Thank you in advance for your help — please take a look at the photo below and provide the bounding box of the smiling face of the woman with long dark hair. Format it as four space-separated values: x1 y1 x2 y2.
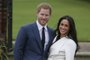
59 19 70 37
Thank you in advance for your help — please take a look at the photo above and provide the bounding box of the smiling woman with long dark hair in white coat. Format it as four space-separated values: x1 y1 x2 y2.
48 16 78 60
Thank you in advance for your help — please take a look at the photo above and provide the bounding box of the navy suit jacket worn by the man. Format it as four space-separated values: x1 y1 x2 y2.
14 23 55 60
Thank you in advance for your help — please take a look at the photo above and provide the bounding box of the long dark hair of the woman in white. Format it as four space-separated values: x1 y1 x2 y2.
55 15 78 52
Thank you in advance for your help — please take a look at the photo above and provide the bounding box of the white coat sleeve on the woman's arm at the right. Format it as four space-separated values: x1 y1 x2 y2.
65 40 76 60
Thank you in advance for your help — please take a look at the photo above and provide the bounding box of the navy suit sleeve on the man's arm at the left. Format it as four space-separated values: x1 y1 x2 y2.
14 27 26 60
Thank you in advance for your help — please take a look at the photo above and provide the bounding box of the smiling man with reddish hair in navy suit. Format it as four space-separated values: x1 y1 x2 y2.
14 3 55 60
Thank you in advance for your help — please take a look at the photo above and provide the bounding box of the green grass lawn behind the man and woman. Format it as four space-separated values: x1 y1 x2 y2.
13 0 90 41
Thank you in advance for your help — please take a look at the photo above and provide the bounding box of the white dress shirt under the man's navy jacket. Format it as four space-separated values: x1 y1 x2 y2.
36 20 49 49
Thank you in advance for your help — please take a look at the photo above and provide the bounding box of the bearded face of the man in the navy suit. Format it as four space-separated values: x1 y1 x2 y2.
37 8 50 26
